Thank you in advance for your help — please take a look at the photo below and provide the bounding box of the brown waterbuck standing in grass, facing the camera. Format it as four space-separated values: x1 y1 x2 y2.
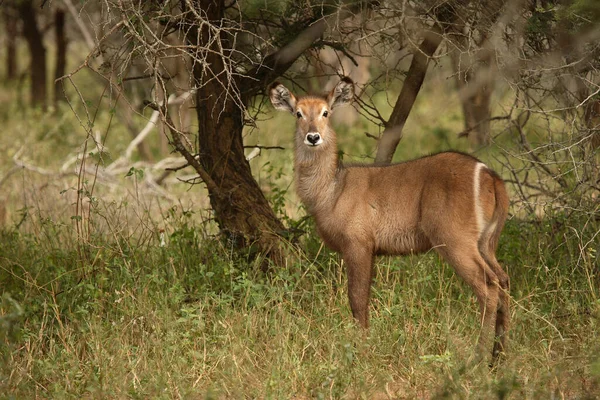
269 78 510 361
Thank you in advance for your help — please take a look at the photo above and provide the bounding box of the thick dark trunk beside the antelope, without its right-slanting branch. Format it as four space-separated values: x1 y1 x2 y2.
193 0 285 264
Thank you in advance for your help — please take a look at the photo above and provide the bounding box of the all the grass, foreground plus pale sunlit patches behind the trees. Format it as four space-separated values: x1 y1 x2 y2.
0 56 600 399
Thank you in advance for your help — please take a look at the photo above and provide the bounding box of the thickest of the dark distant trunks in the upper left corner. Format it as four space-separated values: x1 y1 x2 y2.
19 1 47 109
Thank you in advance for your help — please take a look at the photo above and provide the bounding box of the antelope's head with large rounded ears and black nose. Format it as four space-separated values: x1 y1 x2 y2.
269 77 354 150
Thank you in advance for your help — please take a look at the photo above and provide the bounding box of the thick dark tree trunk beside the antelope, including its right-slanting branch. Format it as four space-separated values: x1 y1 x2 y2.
180 0 366 264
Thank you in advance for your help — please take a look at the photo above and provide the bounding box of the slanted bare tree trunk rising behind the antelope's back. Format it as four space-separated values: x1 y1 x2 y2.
375 29 443 164
